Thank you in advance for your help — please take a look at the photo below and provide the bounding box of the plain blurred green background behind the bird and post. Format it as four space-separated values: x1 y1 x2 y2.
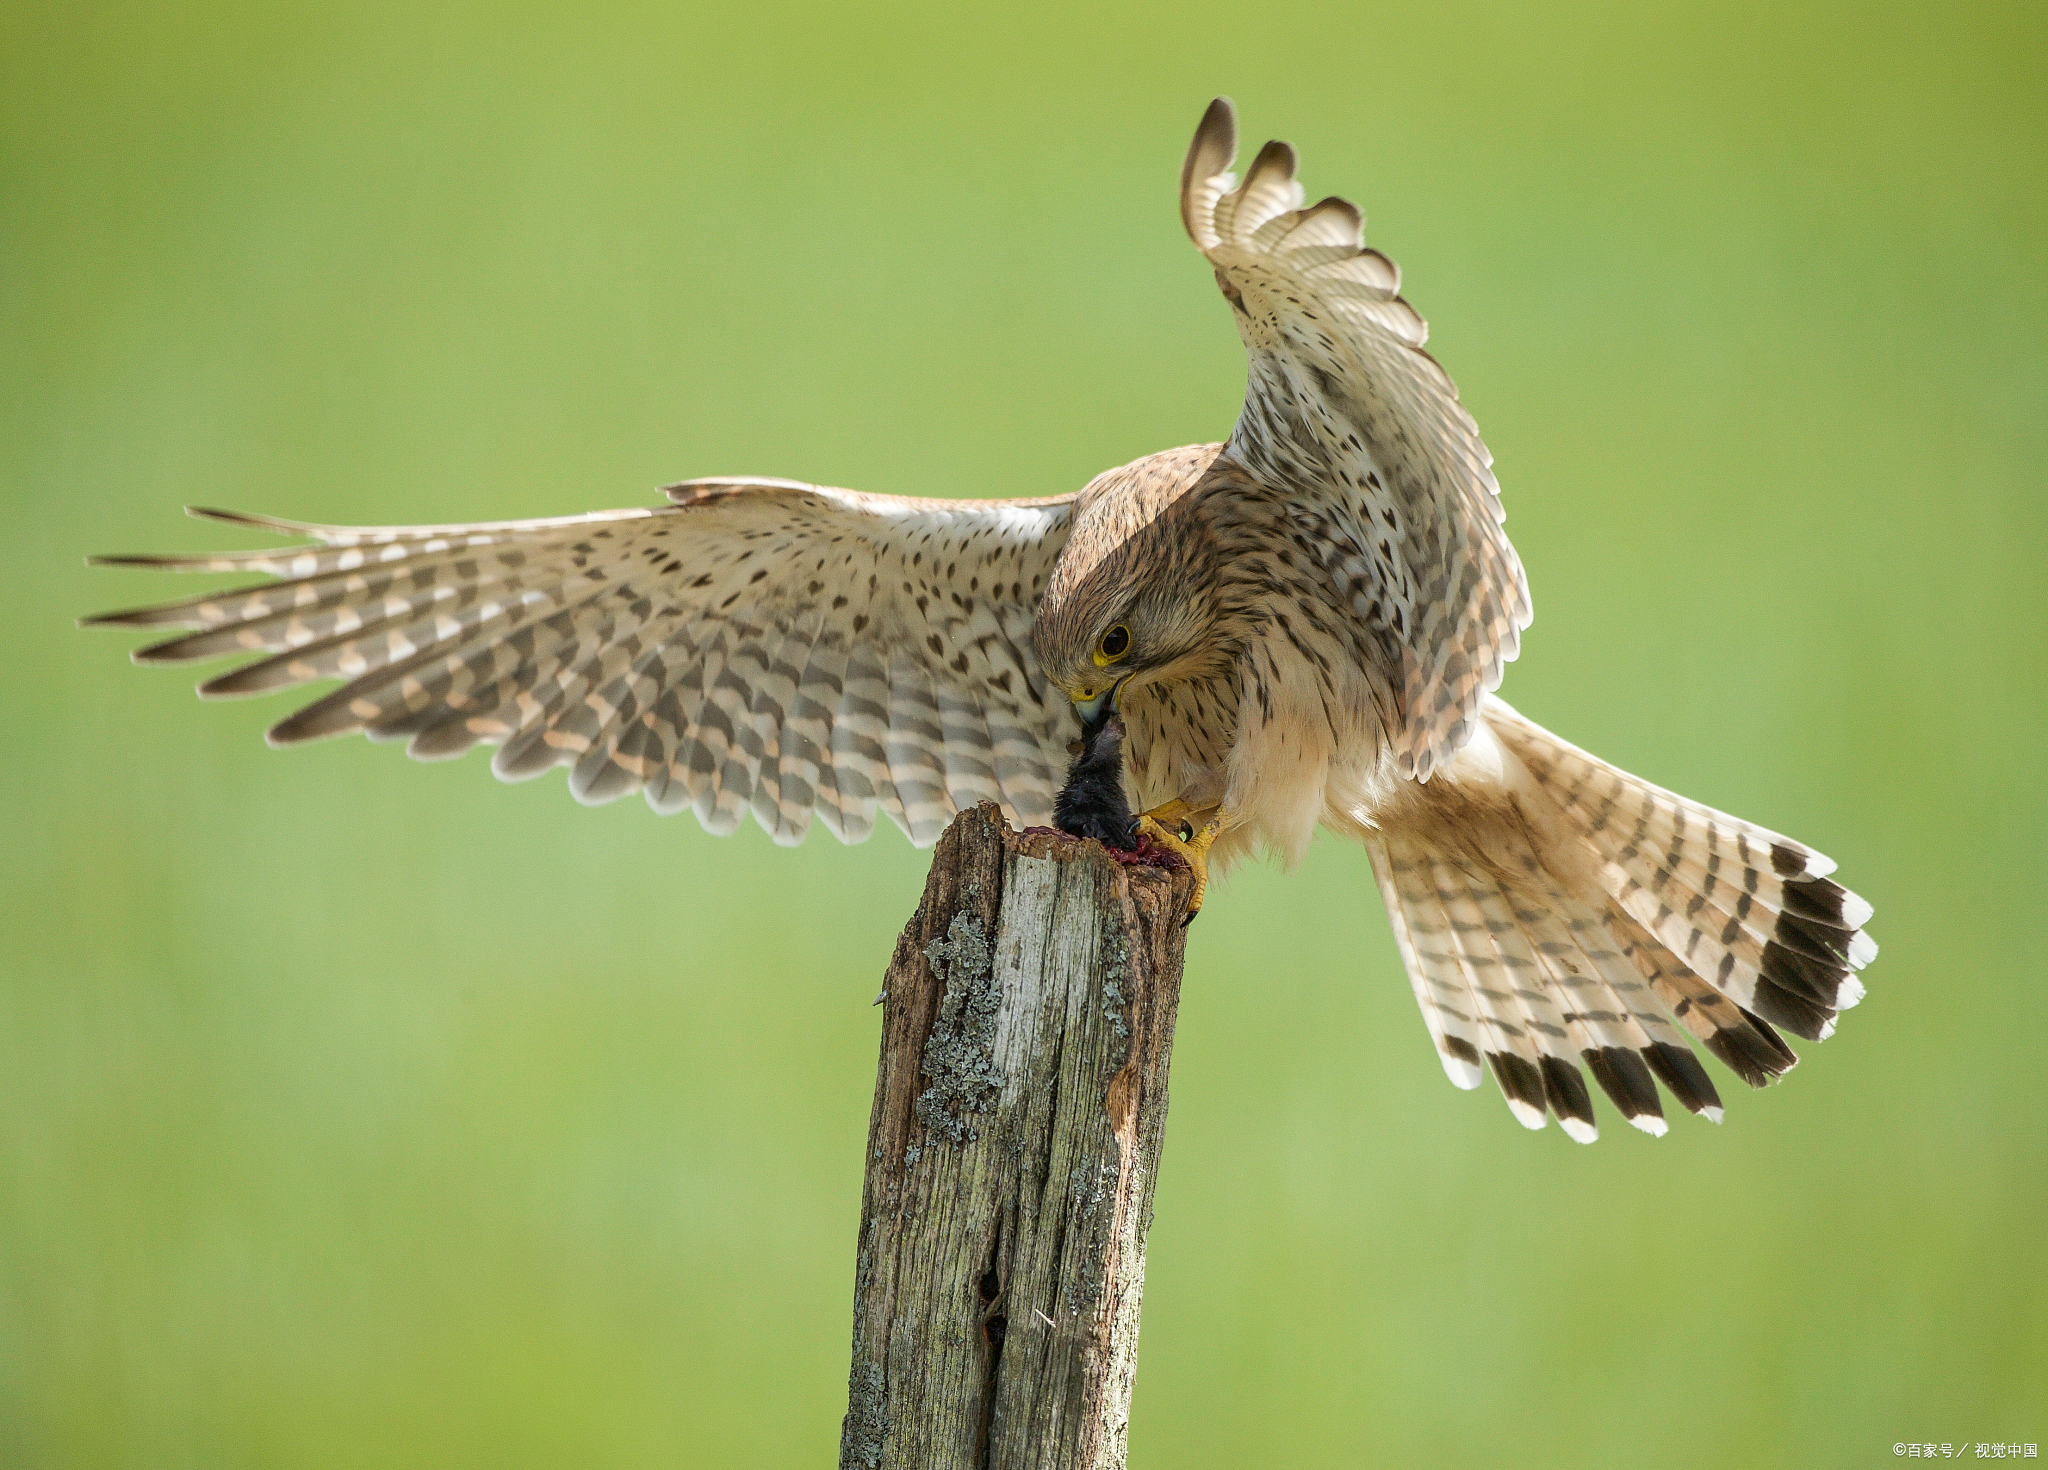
0 0 2048 1466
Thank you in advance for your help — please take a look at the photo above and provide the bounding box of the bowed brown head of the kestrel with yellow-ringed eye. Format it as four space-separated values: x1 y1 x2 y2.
1032 446 1219 725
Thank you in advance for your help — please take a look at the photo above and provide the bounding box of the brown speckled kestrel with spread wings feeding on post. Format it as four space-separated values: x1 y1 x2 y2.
92 98 1876 1140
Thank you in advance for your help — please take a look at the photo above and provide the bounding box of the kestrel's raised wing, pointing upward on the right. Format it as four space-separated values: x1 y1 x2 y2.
1180 98 1530 780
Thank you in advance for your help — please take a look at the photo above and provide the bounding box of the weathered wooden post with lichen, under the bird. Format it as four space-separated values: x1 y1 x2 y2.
840 805 1190 1470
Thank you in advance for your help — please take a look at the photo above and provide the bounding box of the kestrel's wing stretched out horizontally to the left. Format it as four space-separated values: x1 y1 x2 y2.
88 479 1071 846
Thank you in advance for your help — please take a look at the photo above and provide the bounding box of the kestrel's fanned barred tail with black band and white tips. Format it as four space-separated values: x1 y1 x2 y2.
1362 698 1876 1142
